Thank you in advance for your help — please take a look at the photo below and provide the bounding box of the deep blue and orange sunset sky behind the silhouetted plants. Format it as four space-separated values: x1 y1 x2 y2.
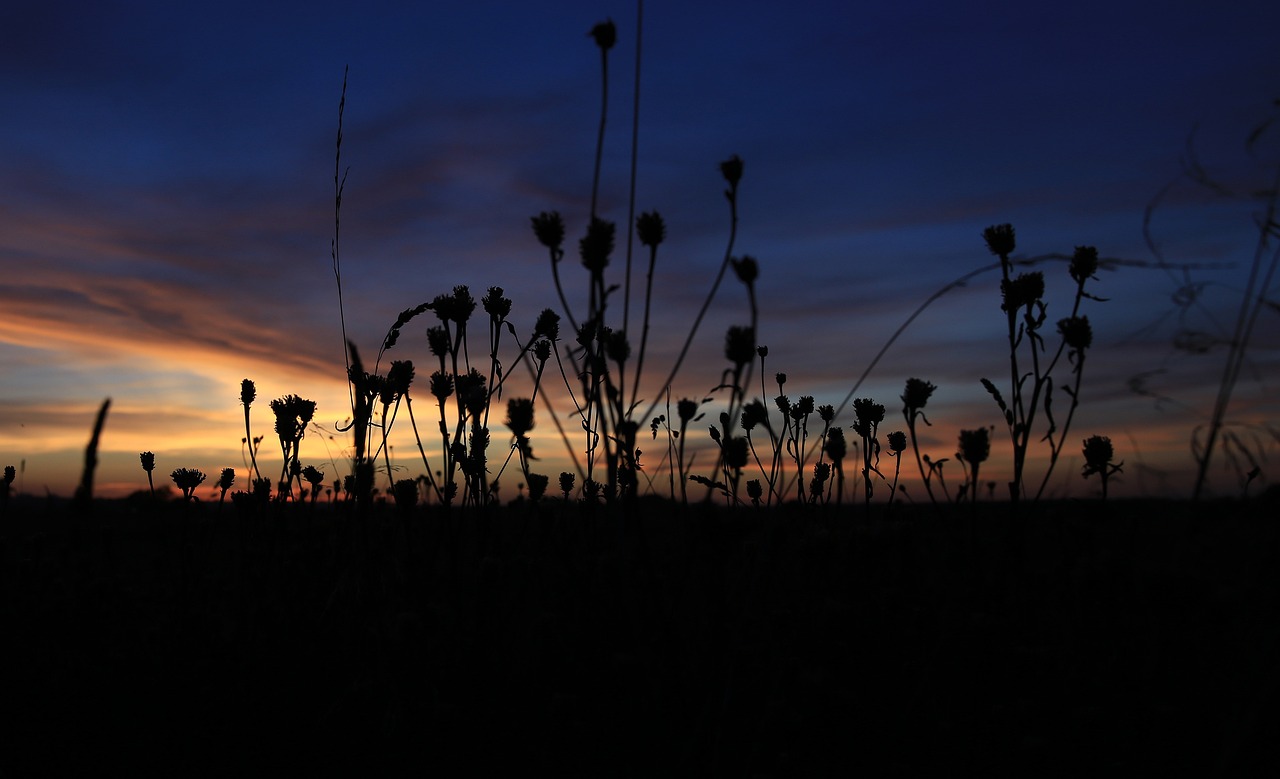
0 0 1280 498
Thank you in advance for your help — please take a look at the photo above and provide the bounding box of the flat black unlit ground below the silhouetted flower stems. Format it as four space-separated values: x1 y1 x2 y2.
0 500 1280 776
